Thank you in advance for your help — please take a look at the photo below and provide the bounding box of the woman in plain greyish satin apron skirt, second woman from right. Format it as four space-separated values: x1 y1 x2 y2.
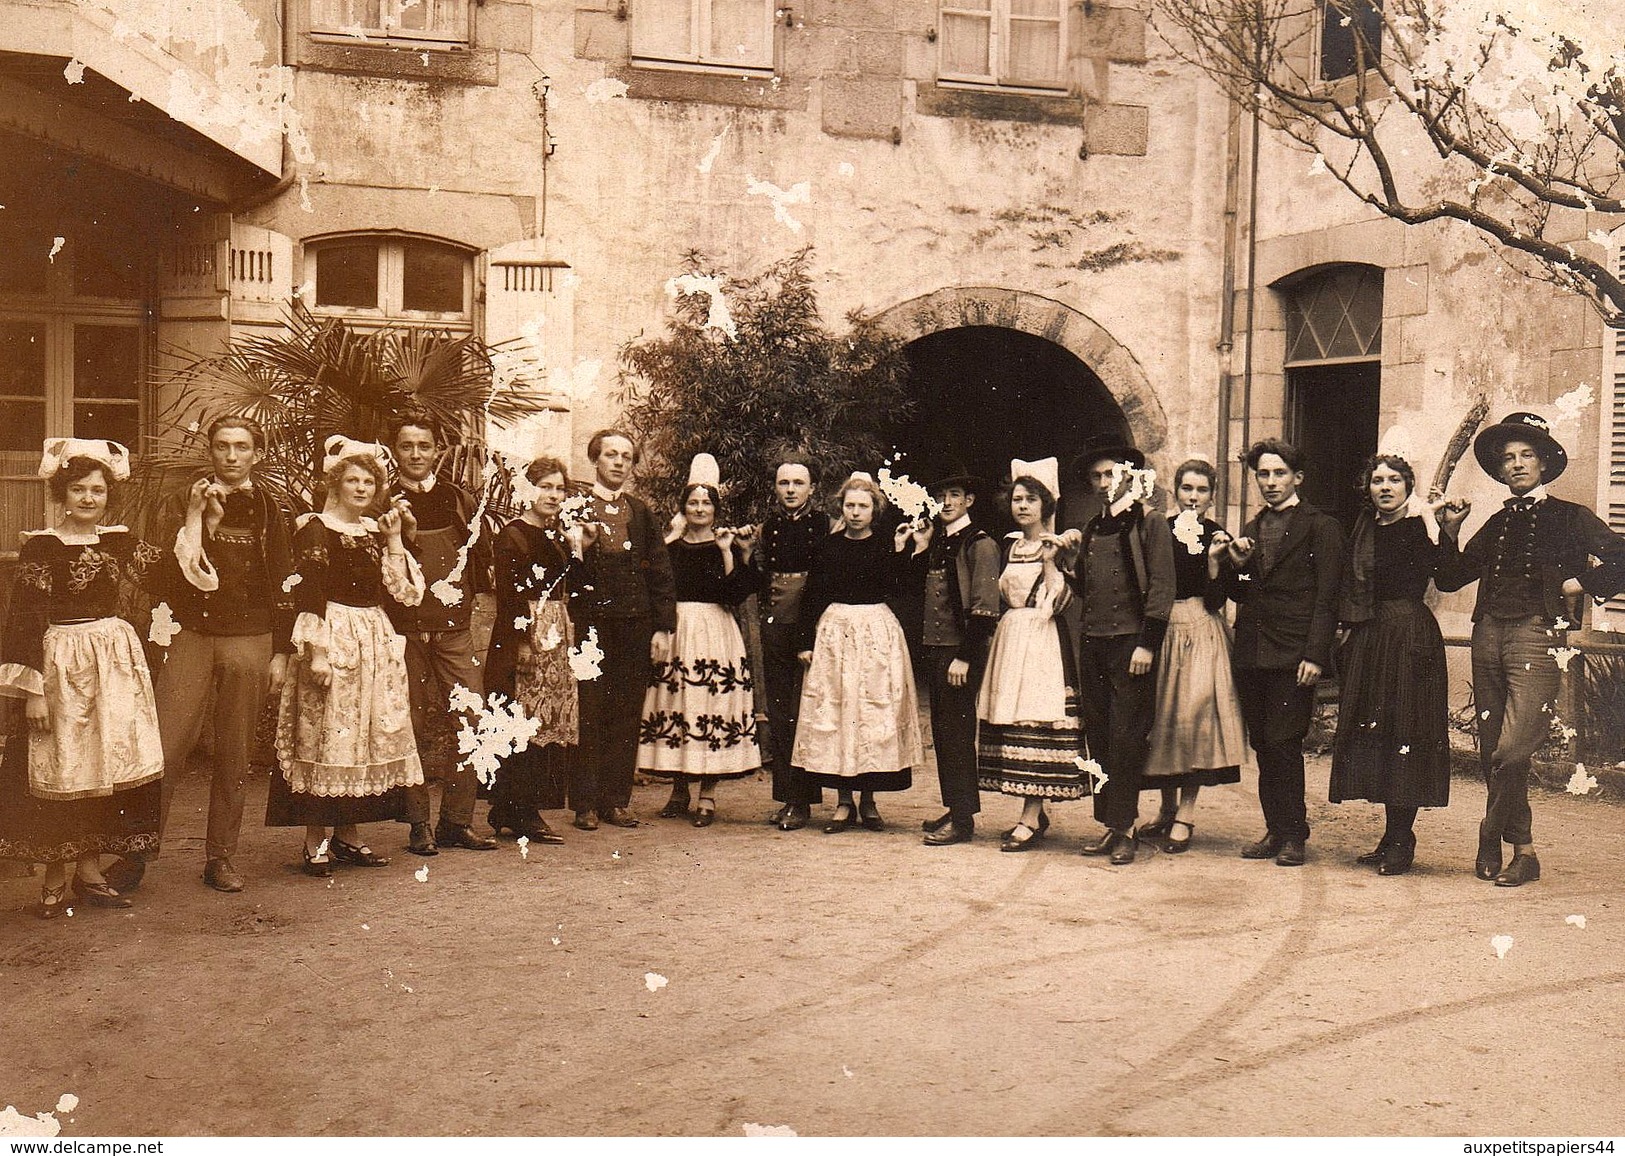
1139 458 1248 855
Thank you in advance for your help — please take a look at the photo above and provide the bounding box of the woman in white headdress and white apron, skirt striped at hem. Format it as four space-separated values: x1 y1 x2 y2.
977 457 1089 850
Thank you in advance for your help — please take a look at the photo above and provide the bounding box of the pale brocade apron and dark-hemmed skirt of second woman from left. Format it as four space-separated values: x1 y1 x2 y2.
265 602 423 828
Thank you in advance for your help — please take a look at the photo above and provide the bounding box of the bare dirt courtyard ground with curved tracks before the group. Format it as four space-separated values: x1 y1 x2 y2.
0 761 1625 1136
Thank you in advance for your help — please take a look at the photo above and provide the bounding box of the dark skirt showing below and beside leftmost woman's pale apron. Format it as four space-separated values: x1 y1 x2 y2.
0 718 163 863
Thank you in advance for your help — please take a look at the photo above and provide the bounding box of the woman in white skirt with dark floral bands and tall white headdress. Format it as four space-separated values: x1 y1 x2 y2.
637 481 762 828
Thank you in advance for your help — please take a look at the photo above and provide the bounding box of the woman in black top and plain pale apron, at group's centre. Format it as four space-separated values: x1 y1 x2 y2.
791 473 923 834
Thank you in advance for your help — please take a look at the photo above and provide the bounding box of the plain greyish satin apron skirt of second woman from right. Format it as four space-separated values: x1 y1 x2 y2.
1144 598 1248 790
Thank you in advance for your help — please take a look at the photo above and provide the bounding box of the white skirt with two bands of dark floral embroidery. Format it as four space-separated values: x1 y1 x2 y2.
637 602 762 779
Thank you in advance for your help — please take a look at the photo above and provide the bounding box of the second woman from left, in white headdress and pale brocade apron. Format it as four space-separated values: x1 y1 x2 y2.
265 434 423 876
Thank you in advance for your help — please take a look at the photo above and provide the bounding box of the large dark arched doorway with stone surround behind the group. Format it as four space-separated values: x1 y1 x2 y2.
879 288 1167 530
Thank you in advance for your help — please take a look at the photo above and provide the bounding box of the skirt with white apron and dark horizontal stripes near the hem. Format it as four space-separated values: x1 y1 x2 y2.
977 606 1089 800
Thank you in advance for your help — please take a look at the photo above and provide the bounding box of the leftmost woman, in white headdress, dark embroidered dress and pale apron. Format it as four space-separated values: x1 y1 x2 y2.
0 437 164 919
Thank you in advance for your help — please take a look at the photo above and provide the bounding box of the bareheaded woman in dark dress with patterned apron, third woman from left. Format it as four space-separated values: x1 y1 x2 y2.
486 457 592 844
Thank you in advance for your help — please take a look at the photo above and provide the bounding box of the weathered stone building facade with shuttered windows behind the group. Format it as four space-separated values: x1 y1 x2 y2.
0 0 1625 650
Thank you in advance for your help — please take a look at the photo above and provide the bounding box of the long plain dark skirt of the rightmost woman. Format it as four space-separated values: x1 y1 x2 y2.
1328 600 1450 806
